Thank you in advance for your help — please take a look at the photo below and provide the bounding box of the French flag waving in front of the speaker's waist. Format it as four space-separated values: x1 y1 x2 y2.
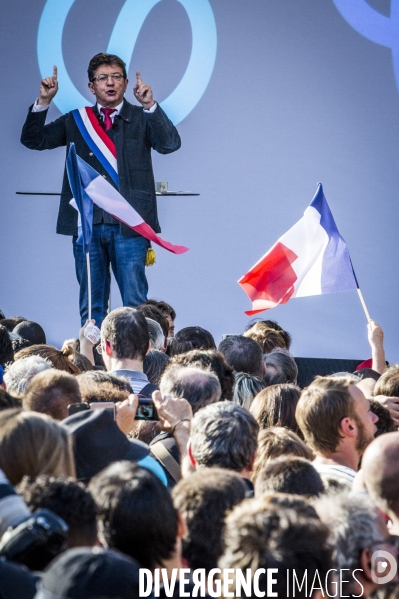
66 143 188 254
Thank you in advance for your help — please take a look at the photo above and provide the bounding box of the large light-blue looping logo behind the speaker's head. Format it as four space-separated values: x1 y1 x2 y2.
37 0 217 125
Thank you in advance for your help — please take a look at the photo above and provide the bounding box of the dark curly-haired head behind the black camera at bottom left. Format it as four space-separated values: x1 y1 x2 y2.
17 476 97 549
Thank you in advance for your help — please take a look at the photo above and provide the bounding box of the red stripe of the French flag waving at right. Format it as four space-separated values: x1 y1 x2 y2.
238 241 298 316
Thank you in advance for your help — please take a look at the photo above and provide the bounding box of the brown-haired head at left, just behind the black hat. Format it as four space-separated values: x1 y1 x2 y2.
22 368 82 420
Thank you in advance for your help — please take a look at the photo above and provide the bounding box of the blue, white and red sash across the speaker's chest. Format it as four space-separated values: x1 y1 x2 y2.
72 106 119 187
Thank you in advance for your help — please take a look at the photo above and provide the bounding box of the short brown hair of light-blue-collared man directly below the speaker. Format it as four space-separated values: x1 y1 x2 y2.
101 308 150 361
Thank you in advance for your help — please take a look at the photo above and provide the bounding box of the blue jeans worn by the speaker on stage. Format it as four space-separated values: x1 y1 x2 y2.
72 224 149 327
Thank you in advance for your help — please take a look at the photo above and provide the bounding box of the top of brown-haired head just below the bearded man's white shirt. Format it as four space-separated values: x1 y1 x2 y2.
255 456 324 497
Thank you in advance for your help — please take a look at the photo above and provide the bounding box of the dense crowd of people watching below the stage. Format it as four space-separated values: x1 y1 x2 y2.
0 300 399 599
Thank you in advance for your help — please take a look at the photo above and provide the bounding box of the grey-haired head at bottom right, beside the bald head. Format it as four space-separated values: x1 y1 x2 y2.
314 494 398 597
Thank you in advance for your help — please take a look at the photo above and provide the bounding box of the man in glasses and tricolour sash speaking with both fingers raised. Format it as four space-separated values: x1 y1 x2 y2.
21 53 181 326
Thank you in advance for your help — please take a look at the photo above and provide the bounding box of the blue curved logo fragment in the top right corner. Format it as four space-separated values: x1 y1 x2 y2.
333 0 399 90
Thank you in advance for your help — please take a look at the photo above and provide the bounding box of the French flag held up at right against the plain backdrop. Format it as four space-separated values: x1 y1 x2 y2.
238 183 359 316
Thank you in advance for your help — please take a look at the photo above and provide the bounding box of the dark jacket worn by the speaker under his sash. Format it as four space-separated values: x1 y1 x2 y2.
21 100 181 235
